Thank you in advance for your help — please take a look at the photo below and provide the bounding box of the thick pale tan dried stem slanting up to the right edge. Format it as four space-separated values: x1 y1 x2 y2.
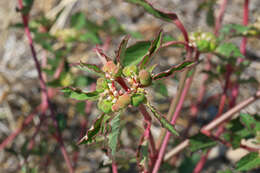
164 90 260 160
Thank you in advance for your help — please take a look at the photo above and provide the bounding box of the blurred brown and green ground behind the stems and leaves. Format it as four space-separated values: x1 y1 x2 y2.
0 0 260 173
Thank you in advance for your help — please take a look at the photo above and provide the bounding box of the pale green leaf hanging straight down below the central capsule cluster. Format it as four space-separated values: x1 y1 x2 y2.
108 113 121 156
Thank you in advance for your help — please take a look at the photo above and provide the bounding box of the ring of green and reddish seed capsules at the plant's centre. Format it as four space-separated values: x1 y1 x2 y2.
96 61 152 113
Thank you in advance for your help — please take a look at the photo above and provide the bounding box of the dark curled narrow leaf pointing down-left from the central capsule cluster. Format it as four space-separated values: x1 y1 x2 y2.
78 114 105 144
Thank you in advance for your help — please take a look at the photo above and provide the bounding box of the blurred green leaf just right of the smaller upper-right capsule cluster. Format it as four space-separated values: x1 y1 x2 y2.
216 43 244 58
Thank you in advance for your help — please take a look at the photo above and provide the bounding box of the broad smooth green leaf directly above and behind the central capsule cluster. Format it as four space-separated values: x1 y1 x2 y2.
121 41 151 67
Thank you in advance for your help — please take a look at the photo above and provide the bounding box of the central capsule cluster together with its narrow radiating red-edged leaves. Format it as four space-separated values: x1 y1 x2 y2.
63 31 194 143
